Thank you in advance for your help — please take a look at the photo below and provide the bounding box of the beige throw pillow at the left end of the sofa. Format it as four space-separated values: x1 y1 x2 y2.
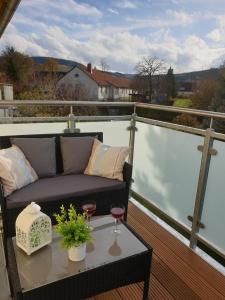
0 145 38 197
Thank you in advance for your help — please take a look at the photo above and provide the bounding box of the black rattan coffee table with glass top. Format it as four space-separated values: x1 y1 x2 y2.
7 216 152 300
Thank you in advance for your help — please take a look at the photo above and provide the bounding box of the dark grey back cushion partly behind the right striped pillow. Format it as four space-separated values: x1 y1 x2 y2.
60 136 94 174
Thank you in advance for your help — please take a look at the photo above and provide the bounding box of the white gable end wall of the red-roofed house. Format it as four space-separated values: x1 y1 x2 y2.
57 67 99 100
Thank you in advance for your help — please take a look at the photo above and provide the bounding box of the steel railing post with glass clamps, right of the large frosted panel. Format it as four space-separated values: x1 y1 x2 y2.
188 128 217 249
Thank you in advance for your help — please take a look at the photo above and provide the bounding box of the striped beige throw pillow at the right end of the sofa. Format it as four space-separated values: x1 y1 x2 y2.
84 139 129 181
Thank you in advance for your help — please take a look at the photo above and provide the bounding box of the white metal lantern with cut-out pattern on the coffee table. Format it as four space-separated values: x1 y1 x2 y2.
16 202 52 255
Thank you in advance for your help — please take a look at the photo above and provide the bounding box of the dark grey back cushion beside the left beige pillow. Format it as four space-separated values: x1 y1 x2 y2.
10 137 56 178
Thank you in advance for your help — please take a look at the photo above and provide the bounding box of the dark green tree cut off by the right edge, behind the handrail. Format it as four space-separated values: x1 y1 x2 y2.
209 65 225 133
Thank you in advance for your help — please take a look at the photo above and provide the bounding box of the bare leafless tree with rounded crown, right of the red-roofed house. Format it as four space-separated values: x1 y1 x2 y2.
135 57 164 103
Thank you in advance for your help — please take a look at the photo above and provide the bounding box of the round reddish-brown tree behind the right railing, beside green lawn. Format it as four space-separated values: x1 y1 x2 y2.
191 79 215 110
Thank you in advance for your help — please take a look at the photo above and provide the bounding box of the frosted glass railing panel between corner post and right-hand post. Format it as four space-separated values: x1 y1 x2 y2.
132 122 203 228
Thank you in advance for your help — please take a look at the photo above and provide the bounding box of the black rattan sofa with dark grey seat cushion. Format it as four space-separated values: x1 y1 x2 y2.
0 132 132 238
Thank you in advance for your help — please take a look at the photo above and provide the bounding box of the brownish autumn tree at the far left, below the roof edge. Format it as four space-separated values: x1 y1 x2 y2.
0 46 33 91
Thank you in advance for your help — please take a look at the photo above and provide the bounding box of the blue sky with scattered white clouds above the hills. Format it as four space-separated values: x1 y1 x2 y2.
0 0 225 73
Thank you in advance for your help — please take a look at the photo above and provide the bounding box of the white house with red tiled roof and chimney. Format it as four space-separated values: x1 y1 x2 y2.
57 63 133 100
